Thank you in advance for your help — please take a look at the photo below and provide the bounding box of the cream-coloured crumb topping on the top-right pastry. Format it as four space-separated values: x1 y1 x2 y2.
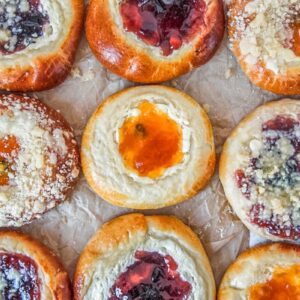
229 0 300 74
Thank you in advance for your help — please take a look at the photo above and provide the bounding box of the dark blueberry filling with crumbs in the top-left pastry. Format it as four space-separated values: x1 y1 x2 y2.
0 0 49 55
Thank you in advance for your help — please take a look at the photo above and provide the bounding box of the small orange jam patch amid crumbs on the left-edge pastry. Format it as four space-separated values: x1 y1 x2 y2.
0 135 20 185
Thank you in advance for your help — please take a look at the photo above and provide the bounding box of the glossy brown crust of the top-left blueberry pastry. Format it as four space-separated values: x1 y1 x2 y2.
0 0 84 92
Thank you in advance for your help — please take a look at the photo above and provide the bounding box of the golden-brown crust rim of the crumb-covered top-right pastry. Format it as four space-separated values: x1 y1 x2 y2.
228 0 300 95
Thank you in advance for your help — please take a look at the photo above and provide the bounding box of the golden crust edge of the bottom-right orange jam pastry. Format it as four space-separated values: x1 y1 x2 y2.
217 243 300 300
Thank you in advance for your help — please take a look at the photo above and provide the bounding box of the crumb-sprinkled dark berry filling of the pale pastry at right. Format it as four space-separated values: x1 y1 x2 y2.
235 116 300 239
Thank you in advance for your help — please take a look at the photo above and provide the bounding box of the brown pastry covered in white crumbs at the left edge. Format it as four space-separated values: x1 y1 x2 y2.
0 95 79 227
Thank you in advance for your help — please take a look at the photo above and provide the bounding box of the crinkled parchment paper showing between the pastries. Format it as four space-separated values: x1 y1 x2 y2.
21 0 300 282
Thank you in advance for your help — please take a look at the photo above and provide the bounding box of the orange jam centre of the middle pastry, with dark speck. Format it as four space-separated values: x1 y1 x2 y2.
119 101 183 178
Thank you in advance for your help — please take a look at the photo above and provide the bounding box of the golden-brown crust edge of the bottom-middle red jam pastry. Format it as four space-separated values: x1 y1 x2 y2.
73 213 216 300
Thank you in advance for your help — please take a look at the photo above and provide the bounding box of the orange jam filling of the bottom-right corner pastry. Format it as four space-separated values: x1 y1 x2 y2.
249 265 300 300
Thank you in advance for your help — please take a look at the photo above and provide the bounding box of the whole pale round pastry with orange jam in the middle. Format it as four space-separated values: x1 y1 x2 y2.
81 86 215 209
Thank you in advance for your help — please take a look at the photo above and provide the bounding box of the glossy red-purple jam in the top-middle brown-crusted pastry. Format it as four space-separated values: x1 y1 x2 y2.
120 0 207 56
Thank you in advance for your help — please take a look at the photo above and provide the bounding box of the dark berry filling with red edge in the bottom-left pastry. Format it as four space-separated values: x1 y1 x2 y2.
0 253 41 300
